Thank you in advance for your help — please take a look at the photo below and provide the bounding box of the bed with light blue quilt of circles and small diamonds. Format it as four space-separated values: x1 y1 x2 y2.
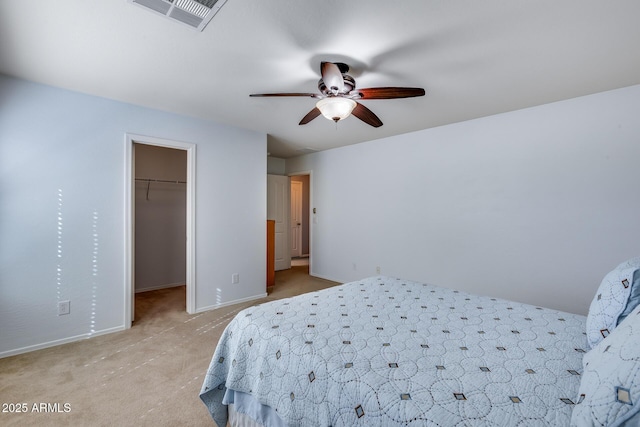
200 258 640 427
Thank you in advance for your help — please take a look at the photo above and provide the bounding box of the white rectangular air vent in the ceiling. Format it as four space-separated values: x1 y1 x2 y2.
127 0 227 31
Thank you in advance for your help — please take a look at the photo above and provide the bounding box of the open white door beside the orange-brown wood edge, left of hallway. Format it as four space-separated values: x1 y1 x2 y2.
267 175 291 271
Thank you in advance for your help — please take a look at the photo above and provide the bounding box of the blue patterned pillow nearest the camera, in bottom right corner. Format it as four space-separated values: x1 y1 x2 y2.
571 306 640 427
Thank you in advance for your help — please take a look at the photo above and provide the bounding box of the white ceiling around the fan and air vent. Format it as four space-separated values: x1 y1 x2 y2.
0 0 640 158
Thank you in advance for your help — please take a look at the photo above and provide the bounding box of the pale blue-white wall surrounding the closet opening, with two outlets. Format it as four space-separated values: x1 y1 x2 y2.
0 75 266 357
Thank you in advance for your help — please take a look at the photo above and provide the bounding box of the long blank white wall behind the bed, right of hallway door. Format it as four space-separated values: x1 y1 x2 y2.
287 86 640 314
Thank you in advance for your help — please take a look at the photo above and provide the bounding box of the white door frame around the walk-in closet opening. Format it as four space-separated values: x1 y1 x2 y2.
124 133 196 329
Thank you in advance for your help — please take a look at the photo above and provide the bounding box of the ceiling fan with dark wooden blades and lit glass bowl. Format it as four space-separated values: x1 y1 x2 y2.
249 62 425 127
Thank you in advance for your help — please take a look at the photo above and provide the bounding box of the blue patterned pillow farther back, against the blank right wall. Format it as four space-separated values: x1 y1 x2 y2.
587 257 640 348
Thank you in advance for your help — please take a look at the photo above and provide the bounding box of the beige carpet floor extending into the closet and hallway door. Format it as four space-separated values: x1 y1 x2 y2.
0 266 336 426
